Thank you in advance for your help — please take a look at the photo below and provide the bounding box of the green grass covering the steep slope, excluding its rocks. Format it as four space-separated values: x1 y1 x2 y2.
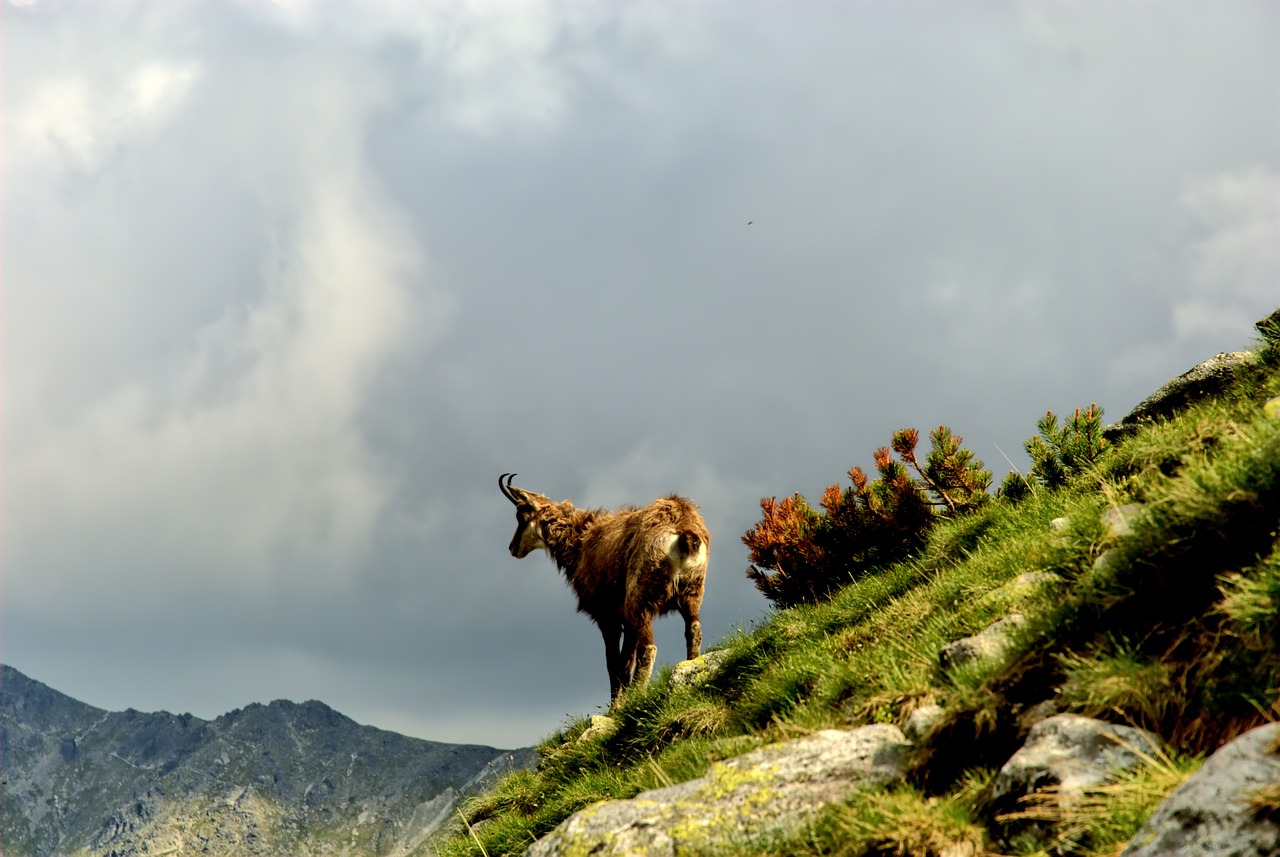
432 332 1280 857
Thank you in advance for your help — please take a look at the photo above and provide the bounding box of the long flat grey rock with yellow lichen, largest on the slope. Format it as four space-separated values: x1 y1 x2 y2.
525 724 910 857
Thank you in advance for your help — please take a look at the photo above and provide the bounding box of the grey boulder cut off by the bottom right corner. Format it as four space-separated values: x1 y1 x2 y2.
1121 723 1280 857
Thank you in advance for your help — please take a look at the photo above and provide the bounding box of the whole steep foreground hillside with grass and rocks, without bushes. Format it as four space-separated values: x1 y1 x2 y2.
430 312 1280 857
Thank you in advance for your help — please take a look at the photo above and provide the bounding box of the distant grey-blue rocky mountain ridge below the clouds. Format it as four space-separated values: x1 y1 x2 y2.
0 666 530 857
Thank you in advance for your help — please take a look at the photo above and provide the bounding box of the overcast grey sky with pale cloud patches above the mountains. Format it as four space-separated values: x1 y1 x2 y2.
0 0 1280 747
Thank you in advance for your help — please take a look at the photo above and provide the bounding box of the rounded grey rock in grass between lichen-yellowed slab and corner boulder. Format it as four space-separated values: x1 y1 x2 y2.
991 714 1160 838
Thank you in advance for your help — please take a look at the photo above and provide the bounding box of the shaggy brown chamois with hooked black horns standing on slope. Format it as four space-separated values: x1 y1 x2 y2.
498 473 712 705
